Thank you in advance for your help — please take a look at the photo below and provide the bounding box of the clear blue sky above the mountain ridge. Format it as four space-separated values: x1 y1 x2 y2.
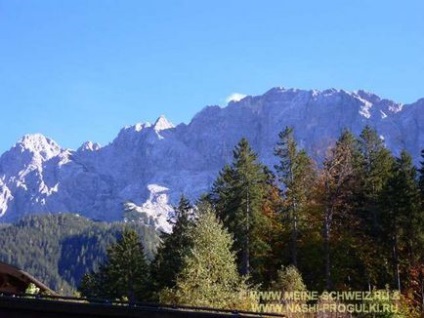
0 0 424 153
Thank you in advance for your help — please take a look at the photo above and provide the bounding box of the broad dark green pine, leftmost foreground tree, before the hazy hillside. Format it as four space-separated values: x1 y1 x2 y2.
79 228 149 302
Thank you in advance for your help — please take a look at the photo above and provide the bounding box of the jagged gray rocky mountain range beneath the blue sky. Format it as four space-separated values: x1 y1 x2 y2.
0 88 424 229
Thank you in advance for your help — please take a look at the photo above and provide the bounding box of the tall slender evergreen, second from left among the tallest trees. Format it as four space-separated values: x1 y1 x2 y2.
274 127 315 267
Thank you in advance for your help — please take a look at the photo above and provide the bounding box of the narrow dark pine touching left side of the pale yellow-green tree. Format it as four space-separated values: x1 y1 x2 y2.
151 196 193 297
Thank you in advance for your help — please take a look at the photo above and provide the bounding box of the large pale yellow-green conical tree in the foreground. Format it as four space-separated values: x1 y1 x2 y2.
161 209 252 308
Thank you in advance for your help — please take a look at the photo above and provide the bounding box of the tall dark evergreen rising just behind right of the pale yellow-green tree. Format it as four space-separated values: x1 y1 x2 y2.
210 138 273 281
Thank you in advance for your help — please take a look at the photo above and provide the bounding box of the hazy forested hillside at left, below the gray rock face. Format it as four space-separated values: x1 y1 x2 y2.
0 214 158 295
